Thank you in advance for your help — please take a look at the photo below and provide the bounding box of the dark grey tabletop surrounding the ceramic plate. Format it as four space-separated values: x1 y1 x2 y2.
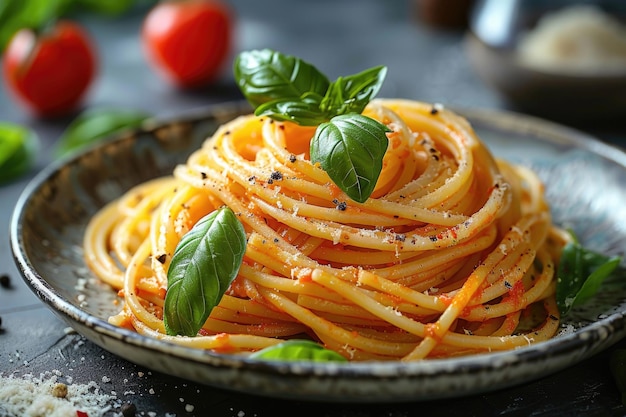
0 0 626 417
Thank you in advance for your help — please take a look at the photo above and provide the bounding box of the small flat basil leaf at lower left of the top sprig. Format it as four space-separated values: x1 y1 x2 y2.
255 98 328 126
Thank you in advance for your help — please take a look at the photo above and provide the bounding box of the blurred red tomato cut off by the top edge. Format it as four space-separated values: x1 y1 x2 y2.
142 0 232 87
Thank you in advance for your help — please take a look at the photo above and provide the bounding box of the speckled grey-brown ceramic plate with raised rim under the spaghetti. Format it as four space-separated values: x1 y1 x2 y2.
11 103 626 402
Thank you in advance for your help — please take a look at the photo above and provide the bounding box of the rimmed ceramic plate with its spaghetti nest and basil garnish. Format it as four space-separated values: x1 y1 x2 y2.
11 50 626 402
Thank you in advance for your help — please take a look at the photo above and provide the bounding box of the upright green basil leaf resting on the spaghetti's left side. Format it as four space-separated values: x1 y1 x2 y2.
163 207 246 336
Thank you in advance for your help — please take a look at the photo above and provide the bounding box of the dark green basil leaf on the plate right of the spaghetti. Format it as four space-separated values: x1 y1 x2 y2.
556 236 621 315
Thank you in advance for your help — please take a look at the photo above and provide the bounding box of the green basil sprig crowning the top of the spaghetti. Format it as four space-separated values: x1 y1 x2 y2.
234 49 390 203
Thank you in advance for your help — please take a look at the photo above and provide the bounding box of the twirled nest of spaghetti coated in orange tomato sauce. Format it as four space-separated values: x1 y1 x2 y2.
85 100 564 361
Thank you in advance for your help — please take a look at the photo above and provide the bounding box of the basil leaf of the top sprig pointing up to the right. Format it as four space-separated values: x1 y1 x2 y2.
320 66 387 115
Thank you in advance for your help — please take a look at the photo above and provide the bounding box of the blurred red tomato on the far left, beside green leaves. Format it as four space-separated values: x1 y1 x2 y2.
3 21 97 117
